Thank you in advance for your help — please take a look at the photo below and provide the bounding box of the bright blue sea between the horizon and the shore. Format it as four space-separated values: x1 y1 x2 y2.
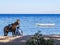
0 14 60 36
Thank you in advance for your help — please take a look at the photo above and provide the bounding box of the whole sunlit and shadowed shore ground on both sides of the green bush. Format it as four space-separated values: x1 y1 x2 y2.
0 35 60 45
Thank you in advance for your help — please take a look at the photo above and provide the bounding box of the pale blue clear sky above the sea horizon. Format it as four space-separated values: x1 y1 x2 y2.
0 0 60 14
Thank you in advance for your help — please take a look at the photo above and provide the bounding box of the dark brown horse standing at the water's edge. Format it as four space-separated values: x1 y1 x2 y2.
4 20 19 36
